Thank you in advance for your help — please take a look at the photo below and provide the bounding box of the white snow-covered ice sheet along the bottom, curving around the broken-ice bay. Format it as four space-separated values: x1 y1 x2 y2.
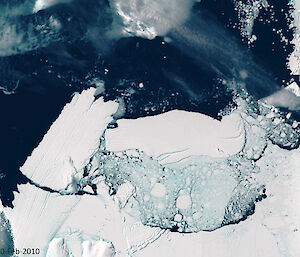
1 131 300 257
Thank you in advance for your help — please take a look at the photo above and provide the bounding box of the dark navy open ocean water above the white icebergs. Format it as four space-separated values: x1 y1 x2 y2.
0 0 297 206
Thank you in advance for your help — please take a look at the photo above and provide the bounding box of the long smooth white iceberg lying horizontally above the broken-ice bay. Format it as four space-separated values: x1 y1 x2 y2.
105 110 245 164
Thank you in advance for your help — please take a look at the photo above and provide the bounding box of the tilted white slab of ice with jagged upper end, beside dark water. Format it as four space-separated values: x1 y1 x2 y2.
20 88 118 192
